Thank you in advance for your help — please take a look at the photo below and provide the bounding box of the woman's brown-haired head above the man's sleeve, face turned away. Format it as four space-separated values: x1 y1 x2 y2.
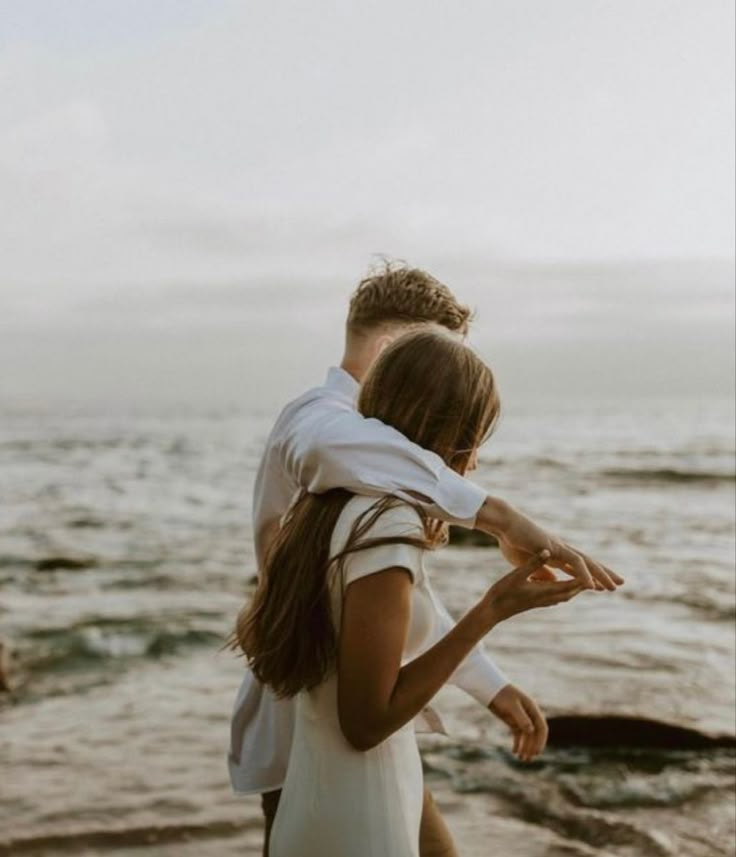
358 328 501 473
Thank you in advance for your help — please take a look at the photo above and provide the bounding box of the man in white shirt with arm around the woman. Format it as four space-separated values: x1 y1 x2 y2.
229 266 622 857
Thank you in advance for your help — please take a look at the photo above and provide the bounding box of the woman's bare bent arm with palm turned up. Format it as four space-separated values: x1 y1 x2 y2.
338 553 583 750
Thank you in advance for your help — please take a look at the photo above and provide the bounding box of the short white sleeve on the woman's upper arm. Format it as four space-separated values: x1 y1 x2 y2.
343 503 424 587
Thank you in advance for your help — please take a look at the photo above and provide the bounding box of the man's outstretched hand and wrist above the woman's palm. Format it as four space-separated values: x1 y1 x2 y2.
476 497 624 592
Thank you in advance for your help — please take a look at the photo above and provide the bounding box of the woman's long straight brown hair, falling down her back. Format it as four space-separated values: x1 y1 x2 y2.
229 329 500 697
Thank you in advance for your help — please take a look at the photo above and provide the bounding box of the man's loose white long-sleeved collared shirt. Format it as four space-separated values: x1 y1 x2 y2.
228 367 508 794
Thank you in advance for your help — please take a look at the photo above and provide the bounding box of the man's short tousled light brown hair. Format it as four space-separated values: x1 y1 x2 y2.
347 262 472 335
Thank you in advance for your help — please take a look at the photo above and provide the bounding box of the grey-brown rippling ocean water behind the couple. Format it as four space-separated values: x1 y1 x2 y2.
0 400 736 857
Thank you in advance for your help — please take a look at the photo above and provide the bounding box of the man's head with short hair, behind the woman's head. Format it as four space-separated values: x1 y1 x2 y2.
343 262 472 378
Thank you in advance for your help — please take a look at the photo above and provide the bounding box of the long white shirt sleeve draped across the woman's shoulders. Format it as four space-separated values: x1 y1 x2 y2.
281 398 487 529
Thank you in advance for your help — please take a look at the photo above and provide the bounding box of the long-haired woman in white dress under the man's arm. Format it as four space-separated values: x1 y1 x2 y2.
236 330 581 857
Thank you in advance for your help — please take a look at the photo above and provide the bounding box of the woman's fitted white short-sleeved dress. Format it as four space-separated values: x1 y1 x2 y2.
269 497 436 857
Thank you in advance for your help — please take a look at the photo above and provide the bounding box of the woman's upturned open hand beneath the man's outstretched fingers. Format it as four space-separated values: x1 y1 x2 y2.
482 550 589 624
